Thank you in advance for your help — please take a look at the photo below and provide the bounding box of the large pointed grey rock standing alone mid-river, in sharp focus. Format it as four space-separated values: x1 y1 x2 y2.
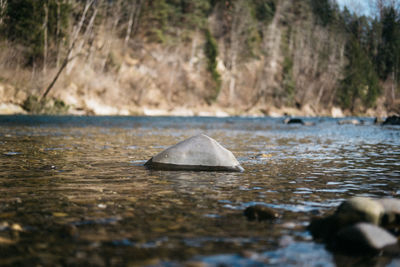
145 134 244 172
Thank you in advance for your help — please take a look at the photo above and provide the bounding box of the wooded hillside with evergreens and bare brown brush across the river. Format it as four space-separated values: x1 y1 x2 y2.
0 0 400 116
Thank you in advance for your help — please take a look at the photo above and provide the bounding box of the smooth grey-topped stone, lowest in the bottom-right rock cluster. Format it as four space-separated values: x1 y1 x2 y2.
336 223 398 253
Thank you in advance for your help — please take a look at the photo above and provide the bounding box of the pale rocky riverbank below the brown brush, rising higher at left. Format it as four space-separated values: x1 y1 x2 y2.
0 83 392 118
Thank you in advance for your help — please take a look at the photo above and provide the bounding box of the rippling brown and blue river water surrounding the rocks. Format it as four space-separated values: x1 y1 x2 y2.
0 116 400 266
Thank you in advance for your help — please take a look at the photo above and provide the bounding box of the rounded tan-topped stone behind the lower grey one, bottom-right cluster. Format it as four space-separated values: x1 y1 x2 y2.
335 197 384 227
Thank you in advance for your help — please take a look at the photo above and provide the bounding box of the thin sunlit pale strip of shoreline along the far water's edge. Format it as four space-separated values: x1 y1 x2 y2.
0 103 392 118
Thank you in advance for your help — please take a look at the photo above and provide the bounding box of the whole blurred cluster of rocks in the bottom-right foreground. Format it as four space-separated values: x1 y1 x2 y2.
308 197 400 253
